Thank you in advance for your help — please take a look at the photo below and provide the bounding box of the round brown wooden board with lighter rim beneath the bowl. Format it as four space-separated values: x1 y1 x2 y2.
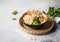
19 14 54 35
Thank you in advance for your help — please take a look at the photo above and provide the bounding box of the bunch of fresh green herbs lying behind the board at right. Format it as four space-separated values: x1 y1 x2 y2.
43 7 60 18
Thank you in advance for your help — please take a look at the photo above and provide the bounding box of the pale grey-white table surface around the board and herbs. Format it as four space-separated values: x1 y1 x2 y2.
0 0 60 42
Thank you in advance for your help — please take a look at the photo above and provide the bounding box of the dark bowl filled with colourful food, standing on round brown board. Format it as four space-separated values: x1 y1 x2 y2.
23 10 47 27
